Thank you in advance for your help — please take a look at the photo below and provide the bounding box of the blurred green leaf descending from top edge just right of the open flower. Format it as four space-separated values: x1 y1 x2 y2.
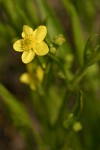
36 0 63 38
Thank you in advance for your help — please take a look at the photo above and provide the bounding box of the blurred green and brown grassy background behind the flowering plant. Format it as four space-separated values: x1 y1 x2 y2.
0 0 100 150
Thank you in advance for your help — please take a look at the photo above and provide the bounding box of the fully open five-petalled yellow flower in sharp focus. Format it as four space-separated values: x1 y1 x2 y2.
13 25 49 64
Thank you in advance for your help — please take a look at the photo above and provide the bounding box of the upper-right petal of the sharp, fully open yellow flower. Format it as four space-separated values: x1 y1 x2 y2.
34 26 47 41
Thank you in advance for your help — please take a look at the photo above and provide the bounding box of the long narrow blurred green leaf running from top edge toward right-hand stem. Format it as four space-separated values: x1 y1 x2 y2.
63 0 85 65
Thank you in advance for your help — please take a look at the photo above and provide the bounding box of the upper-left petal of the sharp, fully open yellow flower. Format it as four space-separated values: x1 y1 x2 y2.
22 25 33 38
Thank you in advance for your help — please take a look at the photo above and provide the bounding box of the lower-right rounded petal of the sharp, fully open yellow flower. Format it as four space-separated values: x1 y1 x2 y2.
34 41 49 56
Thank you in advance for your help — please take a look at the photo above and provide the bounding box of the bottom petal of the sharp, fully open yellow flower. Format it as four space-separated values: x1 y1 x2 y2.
22 50 35 64
